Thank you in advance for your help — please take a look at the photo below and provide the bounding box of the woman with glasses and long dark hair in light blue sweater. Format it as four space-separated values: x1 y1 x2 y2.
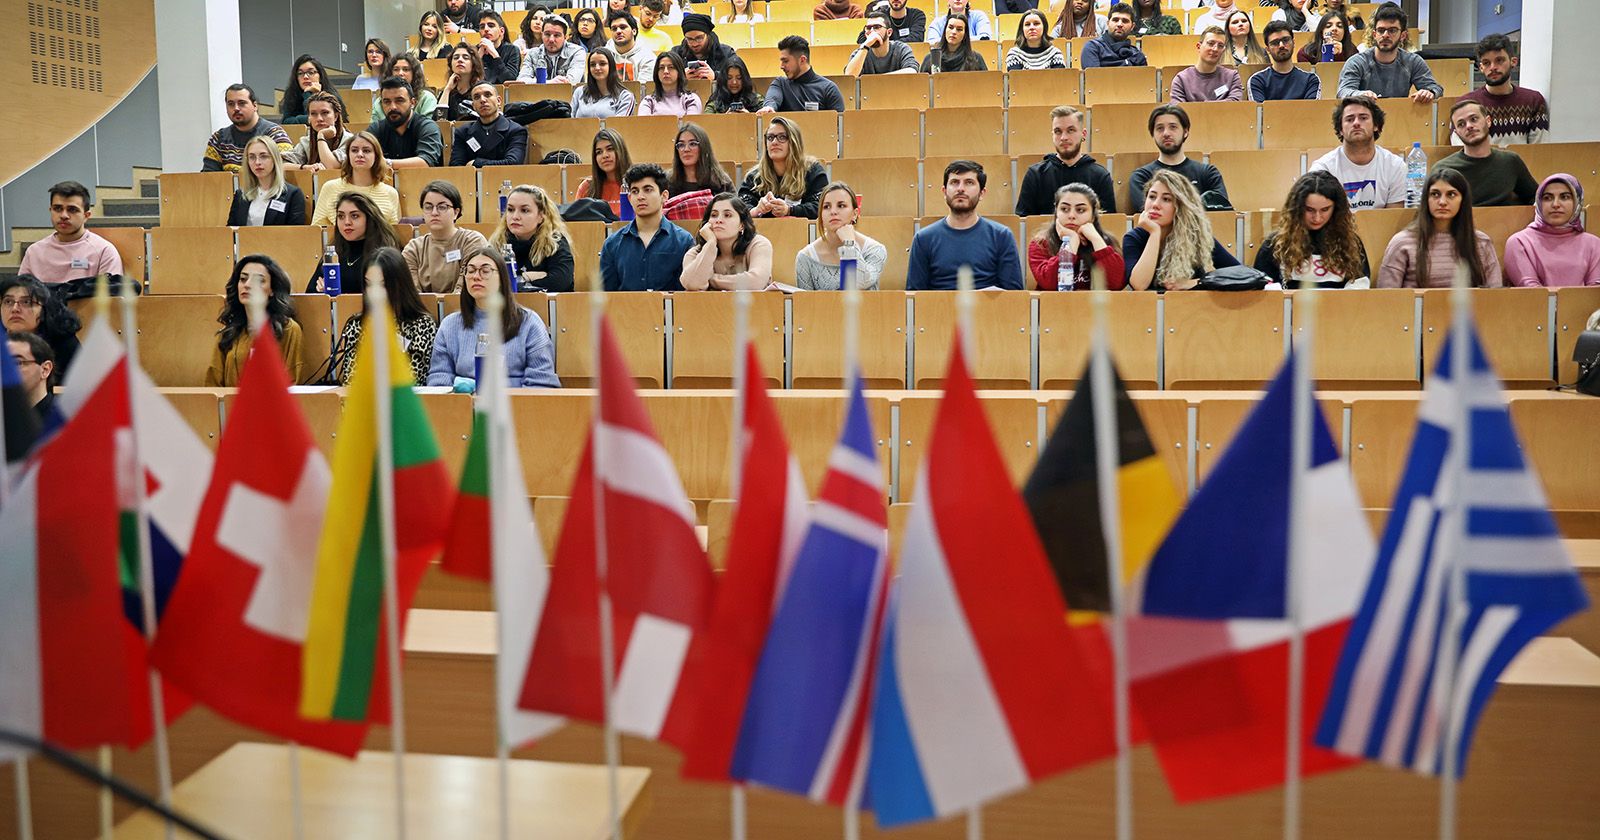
427 248 562 390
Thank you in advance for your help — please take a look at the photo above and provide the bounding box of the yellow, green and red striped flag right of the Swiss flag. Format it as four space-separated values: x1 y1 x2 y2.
301 306 454 723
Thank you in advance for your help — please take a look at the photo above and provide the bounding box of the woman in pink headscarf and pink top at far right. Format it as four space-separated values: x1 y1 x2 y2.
1506 173 1600 286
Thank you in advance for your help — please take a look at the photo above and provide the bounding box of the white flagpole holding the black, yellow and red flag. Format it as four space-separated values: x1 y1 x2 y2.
1090 266 1133 840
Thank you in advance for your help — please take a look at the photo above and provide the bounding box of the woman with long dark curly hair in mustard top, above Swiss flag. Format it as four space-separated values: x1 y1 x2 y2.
205 254 301 387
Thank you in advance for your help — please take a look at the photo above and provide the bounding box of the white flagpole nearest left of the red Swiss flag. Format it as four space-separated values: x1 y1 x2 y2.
122 278 178 840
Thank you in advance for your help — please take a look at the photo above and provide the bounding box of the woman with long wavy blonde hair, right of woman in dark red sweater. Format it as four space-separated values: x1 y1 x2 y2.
1122 170 1238 291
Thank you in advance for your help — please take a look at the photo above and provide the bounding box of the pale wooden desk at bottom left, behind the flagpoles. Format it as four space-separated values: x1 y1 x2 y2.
115 744 650 840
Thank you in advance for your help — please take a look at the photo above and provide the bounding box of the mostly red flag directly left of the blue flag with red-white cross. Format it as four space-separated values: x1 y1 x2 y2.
682 344 806 781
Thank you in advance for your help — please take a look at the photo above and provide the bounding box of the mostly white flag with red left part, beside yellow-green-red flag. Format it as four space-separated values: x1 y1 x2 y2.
440 320 565 749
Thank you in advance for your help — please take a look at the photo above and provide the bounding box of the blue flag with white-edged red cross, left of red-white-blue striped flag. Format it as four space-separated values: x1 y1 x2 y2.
733 369 888 805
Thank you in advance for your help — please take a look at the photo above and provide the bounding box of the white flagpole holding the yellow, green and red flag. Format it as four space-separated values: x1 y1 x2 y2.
363 283 406 840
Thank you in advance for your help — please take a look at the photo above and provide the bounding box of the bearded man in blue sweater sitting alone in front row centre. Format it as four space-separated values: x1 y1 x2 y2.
906 160 1022 291
